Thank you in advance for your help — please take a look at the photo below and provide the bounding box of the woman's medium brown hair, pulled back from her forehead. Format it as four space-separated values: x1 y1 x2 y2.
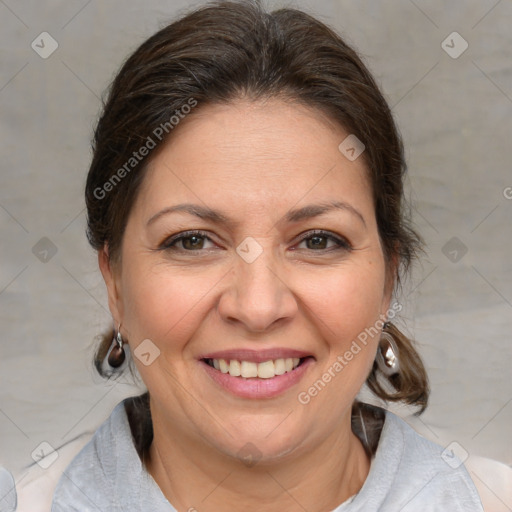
85 1 429 451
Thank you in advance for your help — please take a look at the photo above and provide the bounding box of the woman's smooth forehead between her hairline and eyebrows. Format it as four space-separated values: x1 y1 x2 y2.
135 99 372 221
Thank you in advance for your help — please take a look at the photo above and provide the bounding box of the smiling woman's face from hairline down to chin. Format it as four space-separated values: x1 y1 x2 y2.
100 100 392 461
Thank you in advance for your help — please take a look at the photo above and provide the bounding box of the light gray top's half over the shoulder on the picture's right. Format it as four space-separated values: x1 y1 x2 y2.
344 404 483 512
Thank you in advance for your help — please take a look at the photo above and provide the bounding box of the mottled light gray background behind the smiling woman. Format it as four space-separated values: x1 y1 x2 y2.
0 0 512 504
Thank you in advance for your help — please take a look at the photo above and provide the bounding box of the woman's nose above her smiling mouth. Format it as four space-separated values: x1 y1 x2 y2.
218 249 298 332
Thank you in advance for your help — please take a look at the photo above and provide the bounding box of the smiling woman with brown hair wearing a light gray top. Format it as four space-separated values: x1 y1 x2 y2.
53 2 482 512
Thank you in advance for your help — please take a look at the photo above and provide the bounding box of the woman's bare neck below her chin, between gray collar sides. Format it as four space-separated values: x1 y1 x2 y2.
146 410 370 512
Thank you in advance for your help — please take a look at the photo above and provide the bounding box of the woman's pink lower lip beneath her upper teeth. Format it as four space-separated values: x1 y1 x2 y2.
199 357 314 399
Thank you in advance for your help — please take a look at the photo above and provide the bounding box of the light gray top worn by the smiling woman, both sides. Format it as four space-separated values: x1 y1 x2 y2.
52 402 483 512
